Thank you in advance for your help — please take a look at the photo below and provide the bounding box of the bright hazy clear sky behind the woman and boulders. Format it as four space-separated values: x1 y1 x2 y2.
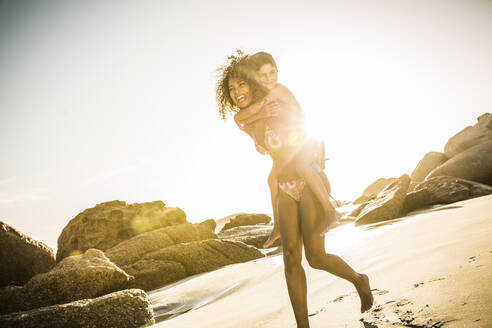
0 0 492 248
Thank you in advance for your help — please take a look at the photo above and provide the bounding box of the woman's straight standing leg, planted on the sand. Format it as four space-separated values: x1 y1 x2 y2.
277 188 309 328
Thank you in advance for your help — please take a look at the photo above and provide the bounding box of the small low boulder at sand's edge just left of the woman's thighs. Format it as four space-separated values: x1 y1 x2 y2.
219 225 280 248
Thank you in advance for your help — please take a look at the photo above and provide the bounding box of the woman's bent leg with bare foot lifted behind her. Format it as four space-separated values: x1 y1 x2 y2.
299 186 374 312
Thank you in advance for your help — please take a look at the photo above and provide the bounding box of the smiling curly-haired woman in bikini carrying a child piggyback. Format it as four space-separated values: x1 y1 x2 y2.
217 53 373 328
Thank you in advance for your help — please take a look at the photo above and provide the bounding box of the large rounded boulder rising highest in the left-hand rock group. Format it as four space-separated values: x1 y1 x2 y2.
56 200 186 261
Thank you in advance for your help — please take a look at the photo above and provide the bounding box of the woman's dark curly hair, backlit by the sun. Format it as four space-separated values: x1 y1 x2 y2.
215 50 268 121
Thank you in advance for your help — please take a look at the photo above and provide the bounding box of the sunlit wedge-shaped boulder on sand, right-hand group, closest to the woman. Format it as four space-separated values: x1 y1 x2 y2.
355 174 410 226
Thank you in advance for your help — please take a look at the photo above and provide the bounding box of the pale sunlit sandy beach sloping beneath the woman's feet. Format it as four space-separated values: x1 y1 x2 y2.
150 196 492 328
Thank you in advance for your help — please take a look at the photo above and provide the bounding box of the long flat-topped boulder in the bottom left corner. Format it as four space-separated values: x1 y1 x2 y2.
0 289 155 328
